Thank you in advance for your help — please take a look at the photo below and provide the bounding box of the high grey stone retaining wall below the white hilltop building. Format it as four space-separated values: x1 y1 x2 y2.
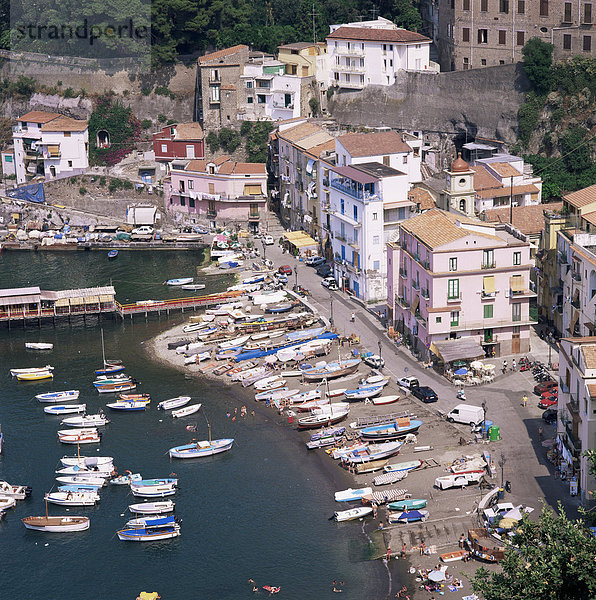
329 63 529 143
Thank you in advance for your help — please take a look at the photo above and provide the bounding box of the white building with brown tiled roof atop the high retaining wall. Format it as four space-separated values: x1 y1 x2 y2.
321 18 437 89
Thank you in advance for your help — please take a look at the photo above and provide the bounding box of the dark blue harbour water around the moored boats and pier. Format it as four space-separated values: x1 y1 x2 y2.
0 252 387 600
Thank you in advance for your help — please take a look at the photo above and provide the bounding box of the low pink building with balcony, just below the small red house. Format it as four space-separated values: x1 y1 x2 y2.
164 156 267 231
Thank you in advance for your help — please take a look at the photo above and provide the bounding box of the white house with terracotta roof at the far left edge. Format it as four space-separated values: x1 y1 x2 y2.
12 111 89 184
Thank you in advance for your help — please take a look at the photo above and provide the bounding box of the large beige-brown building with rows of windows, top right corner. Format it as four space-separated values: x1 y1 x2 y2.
421 0 596 71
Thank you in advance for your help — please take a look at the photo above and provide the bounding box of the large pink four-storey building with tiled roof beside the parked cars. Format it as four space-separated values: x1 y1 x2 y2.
387 209 535 362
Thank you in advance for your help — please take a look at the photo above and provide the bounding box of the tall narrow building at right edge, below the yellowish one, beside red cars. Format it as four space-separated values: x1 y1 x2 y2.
557 336 596 500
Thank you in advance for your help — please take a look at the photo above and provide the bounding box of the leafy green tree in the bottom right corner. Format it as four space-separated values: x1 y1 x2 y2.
472 504 596 600
